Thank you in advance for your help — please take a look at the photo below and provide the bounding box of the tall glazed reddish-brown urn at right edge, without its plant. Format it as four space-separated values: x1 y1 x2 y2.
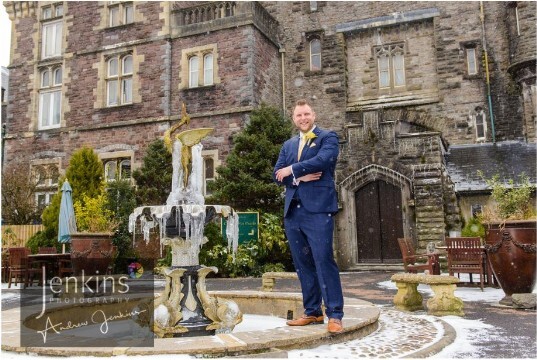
485 220 537 306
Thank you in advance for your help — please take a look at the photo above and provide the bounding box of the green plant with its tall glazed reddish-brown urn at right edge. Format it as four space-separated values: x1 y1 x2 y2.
481 174 537 305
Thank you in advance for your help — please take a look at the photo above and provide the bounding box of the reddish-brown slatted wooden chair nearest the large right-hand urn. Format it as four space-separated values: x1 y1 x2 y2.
446 237 485 291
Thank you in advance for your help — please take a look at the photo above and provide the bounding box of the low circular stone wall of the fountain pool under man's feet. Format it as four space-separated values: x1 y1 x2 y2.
2 291 380 356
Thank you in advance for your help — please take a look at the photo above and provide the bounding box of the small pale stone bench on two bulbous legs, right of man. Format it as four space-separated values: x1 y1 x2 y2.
391 273 464 316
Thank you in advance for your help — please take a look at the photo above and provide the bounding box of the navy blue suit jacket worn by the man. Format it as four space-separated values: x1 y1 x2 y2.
273 126 339 216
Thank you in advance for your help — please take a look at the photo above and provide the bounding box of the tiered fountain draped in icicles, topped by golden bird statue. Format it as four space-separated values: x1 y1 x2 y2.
129 104 242 338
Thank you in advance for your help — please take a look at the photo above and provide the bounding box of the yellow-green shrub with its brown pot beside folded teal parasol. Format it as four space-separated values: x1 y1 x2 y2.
71 192 119 275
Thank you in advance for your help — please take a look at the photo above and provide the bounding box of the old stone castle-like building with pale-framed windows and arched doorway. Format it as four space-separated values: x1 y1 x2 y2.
4 1 537 270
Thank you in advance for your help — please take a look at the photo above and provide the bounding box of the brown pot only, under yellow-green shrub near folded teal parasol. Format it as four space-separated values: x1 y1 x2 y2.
71 233 116 276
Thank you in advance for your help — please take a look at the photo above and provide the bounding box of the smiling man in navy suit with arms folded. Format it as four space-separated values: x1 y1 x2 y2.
274 100 343 333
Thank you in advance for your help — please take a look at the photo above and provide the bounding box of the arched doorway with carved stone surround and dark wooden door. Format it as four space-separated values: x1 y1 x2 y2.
336 165 414 270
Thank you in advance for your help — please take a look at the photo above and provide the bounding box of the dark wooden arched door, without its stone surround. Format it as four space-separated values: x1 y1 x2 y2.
355 180 403 263
